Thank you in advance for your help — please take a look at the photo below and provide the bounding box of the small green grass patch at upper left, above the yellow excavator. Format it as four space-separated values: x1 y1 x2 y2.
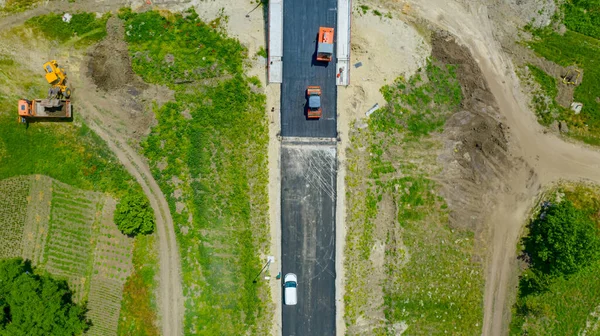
25 13 110 46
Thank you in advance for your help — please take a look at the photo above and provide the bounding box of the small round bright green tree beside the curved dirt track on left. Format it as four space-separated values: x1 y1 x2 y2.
114 193 154 236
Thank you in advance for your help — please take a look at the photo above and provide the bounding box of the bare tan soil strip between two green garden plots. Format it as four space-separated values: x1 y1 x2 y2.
21 175 52 265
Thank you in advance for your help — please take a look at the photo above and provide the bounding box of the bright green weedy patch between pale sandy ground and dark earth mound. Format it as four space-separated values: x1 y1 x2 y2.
378 62 462 139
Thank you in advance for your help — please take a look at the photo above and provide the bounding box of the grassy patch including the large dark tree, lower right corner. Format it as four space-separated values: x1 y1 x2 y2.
511 184 600 335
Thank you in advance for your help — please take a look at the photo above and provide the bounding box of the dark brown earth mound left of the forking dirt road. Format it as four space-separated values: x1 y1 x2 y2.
432 32 536 236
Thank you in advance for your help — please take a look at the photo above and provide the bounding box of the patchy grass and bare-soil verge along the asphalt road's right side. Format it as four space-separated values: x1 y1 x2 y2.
344 62 484 335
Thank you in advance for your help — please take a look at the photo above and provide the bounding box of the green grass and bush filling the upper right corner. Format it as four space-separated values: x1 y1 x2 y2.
528 0 600 145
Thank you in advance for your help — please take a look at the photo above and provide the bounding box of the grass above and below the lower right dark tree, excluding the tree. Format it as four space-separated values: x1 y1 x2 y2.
511 185 600 335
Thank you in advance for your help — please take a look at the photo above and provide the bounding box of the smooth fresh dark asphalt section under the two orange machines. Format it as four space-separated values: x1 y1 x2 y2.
281 0 337 138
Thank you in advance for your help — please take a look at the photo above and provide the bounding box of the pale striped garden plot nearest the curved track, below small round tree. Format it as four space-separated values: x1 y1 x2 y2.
87 199 133 335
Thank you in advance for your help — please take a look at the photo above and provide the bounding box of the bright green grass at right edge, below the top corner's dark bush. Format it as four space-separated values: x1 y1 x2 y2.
528 26 600 144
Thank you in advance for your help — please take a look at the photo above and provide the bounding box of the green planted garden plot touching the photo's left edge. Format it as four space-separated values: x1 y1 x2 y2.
0 176 31 258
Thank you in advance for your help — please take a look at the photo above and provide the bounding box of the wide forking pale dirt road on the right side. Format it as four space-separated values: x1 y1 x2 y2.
409 0 600 335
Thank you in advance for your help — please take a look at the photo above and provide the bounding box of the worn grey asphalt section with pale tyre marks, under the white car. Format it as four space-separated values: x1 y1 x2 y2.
281 142 337 336
